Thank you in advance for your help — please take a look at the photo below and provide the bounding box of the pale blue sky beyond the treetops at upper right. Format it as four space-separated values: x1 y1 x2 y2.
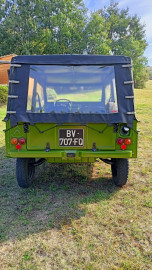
84 0 152 66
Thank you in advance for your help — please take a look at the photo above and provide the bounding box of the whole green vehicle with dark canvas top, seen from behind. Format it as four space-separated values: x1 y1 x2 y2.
5 55 138 188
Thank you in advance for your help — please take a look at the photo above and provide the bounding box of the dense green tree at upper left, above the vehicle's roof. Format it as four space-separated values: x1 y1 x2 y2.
0 0 86 54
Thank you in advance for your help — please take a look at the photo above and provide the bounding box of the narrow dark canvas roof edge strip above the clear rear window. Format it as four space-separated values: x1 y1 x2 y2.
11 54 131 65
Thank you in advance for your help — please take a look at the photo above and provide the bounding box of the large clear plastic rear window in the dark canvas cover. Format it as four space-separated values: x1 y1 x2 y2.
27 65 118 114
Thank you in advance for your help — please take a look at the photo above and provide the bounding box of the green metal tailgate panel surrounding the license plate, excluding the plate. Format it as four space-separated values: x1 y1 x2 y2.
27 124 116 150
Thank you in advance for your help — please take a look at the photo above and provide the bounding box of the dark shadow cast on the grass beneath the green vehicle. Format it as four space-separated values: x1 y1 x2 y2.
0 152 119 241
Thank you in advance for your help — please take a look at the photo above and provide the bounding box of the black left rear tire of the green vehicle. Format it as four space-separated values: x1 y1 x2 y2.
16 158 35 188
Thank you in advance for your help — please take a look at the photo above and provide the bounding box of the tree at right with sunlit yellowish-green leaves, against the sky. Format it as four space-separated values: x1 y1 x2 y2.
98 1 148 87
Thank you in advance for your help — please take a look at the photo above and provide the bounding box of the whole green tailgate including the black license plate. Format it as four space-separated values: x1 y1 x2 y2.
27 124 116 150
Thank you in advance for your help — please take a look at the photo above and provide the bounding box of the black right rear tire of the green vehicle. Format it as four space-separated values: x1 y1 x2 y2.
111 158 129 187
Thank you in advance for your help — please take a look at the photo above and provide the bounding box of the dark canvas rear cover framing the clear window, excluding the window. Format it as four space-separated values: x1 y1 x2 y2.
5 55 135 127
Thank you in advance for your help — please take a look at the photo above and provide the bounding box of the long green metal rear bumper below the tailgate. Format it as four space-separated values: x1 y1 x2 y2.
7 150 133 162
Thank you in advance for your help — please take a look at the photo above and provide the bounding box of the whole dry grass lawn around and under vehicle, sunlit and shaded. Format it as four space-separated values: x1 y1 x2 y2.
0 81 152 270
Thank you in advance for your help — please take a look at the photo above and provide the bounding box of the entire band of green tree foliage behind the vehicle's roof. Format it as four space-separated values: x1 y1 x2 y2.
0 0 147 86
